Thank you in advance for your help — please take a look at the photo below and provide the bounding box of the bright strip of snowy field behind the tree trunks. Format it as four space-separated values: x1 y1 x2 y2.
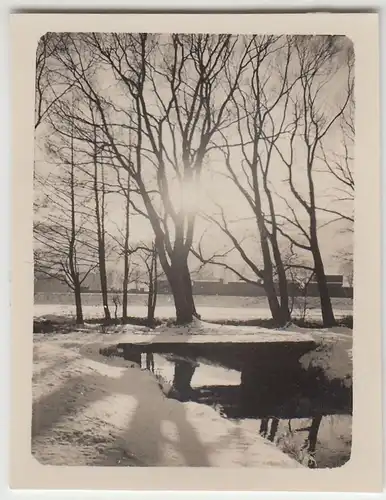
34 304 352 321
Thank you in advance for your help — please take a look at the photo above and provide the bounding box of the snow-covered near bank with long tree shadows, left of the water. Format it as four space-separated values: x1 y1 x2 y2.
32 326 300 468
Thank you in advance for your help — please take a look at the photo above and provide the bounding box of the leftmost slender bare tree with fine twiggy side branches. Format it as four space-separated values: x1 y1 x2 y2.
34 121 97 324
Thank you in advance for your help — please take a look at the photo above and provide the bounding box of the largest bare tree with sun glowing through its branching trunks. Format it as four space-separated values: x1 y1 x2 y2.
61 34 258 323
